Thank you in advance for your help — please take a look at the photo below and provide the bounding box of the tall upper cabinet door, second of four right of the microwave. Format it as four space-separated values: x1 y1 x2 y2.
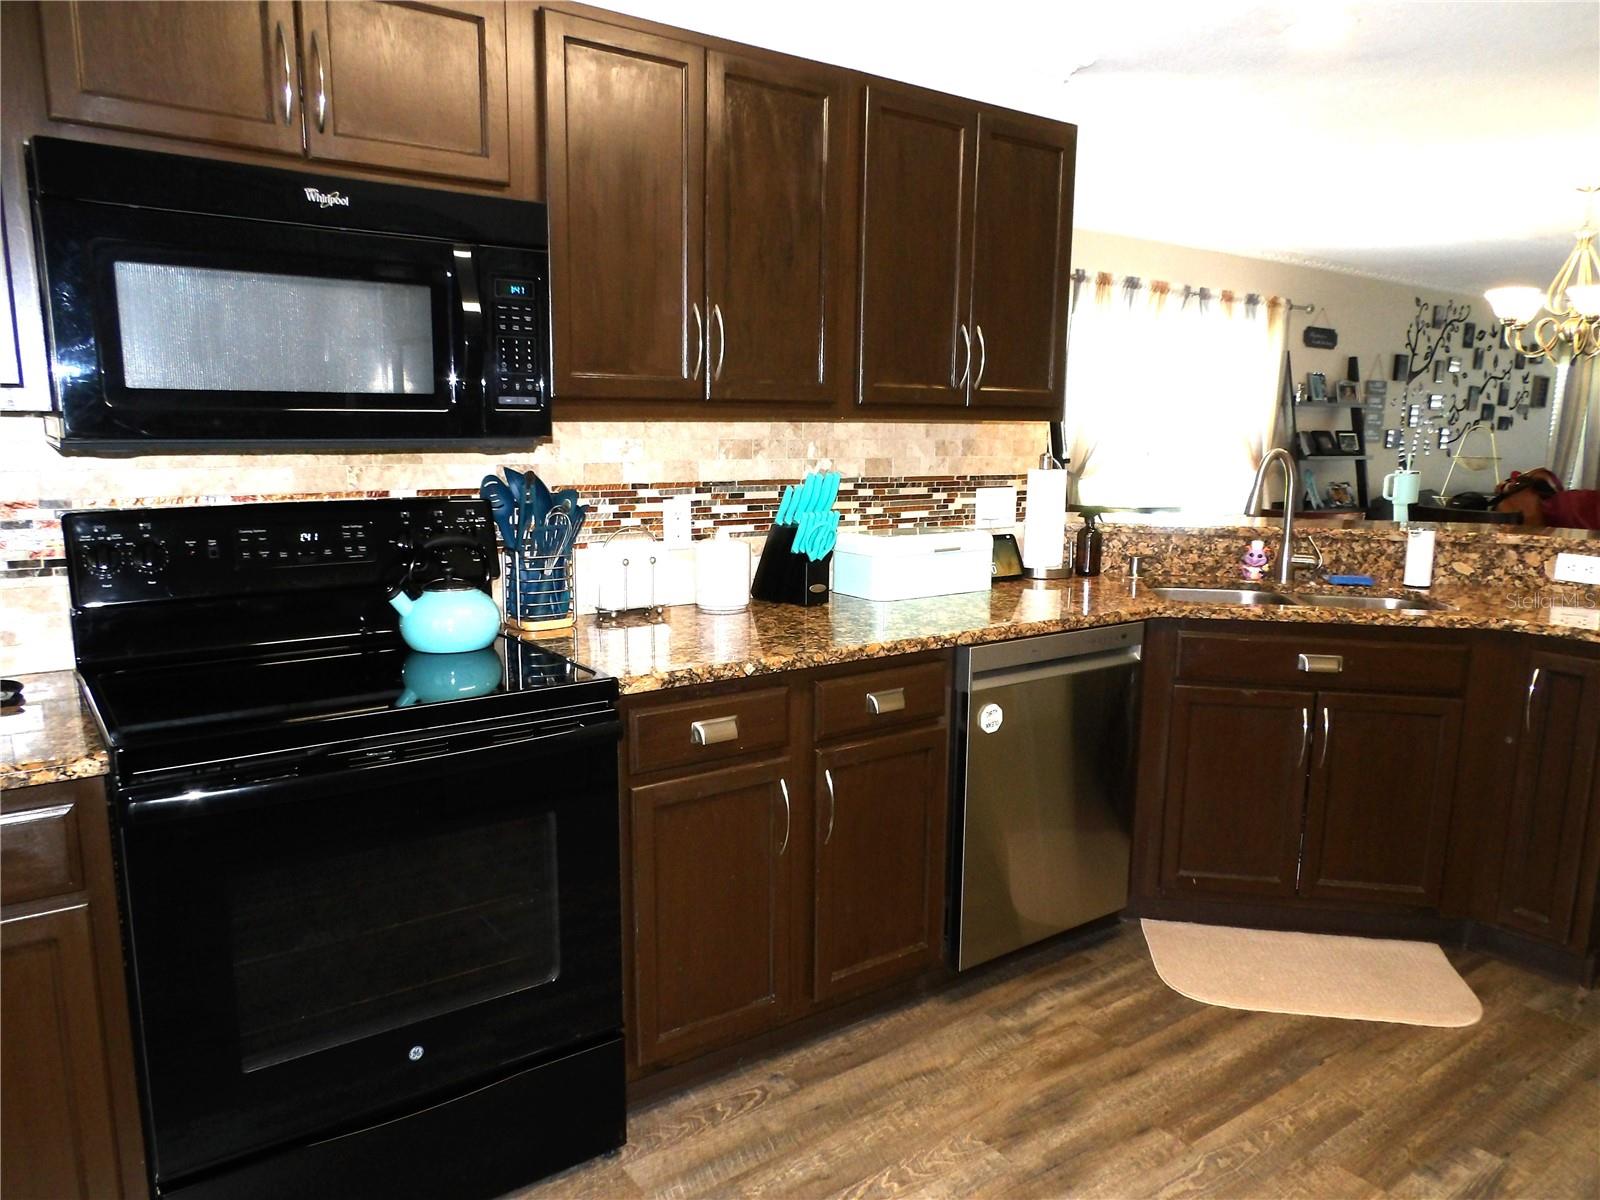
706 53 854 403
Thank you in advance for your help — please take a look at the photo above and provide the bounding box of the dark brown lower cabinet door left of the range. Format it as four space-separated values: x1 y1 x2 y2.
0 899 123 1200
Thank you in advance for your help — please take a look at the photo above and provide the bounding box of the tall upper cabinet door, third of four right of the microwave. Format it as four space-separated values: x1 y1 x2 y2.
859 86 978 406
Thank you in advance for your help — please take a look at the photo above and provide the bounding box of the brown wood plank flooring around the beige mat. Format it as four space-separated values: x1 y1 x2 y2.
517 925 1600 1200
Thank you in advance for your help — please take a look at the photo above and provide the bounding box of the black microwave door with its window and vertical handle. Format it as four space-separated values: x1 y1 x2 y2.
38 197 485 445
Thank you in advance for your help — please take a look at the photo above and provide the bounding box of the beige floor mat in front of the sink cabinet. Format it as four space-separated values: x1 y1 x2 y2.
1142 920 1483 1027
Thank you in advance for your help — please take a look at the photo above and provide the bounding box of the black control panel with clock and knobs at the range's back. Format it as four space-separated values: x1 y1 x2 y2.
61 498 494 606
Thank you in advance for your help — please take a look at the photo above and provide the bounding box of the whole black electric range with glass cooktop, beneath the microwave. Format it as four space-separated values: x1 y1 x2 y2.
64 499 626 1198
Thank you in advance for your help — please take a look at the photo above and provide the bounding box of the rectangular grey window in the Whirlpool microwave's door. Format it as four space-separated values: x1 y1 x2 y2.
115 262 435 395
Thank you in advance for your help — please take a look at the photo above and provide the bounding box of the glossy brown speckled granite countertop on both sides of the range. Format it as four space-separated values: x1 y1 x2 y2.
0 574 1600 787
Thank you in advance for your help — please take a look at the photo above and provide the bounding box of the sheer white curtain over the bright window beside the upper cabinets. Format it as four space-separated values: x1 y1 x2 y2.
1066 274 1285 515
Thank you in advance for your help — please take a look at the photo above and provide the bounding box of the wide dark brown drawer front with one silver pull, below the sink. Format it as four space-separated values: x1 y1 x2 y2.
1178 630 1469 693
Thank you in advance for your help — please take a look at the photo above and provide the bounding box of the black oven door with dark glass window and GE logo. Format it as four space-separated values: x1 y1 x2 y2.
118 714 622 1184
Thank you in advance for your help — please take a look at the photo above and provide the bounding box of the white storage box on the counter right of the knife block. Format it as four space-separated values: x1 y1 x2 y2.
834 530 994 600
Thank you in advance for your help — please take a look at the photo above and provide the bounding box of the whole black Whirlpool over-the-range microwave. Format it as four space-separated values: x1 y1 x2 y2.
27 138 550 454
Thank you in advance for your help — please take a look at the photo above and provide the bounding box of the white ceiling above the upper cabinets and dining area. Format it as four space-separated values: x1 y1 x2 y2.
602 0 1600 291
